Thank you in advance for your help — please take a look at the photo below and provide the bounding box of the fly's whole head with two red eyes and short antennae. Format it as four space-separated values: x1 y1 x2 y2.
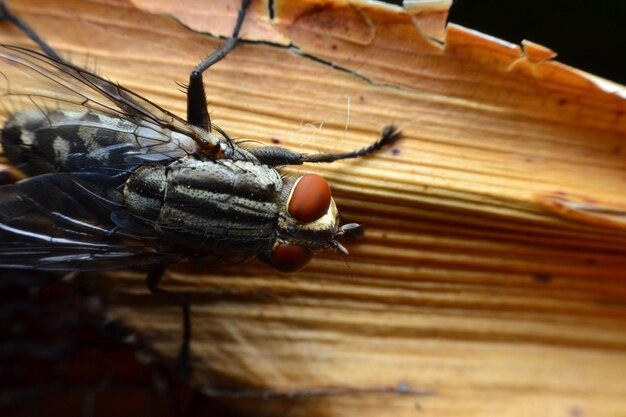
271 174 359 272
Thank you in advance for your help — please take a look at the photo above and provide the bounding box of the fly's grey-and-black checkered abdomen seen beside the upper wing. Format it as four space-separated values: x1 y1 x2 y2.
2 110 196 175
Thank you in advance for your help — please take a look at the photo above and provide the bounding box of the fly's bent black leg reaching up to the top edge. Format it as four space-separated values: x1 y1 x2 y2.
187 0 250 131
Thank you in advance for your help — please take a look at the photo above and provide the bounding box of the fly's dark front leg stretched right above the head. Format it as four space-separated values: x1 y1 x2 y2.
251 125 402 166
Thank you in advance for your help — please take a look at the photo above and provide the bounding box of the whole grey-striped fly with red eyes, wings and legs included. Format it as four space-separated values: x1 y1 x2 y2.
0 0 399 374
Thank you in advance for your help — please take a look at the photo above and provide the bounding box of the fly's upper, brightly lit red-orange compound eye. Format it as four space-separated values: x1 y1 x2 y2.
289 174 330 222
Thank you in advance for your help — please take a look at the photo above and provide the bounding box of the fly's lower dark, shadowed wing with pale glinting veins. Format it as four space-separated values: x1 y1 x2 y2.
0 173 183 271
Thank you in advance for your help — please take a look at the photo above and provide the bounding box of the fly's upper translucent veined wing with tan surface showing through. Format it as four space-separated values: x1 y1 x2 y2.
0 45 232 159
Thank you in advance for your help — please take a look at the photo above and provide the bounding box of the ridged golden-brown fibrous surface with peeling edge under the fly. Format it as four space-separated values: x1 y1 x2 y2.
0 0 626 417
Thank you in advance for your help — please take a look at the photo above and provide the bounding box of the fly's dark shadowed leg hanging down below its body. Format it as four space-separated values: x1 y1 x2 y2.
146 265 191 379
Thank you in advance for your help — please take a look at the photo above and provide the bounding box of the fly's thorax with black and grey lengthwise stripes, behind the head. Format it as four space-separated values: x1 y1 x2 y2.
124 158 283 256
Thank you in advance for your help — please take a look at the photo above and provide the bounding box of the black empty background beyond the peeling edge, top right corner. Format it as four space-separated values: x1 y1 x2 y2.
389 0 626 84
